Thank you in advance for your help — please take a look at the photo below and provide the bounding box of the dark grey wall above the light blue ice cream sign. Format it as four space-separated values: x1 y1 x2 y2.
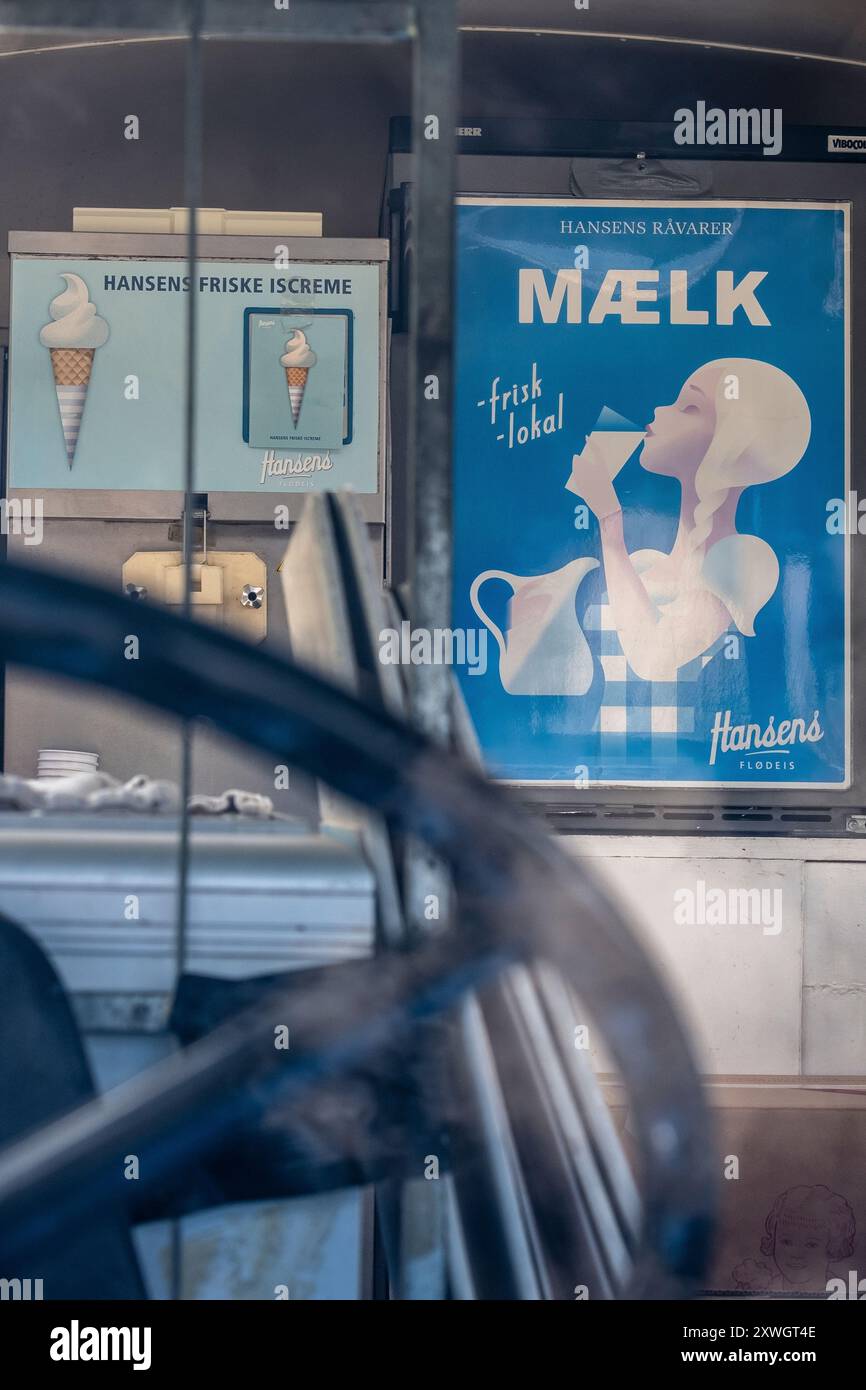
0 42 409 341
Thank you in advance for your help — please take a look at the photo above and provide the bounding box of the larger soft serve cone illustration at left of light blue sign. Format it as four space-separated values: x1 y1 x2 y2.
39 274 108 468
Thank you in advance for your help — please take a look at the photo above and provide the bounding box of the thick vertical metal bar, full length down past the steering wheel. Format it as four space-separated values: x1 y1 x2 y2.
392 0 460 1298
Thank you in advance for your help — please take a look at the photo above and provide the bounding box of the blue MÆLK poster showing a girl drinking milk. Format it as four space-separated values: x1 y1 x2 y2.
453 197 849 788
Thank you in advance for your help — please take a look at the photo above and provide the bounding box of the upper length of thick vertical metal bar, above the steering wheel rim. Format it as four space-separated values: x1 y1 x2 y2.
409 0 459 742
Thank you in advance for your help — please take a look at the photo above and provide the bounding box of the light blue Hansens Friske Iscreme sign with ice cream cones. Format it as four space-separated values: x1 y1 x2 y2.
10 257 381 493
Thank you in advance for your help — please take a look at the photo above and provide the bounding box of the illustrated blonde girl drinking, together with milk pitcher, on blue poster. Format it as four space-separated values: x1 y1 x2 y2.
471 357 812 734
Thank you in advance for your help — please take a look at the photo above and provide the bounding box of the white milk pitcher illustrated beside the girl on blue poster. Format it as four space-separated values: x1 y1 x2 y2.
470 559 599 695
